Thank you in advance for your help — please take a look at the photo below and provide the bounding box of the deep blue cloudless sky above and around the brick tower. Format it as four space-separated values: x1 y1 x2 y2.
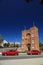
0 0 43 42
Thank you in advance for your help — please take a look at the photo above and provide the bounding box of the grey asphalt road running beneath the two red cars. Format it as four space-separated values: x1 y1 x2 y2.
0 54 43 60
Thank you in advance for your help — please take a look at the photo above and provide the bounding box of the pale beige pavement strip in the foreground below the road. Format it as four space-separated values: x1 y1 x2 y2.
0 58 43 65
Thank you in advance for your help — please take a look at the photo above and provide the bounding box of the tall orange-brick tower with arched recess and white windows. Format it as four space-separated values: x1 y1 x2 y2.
22 26 39 50
